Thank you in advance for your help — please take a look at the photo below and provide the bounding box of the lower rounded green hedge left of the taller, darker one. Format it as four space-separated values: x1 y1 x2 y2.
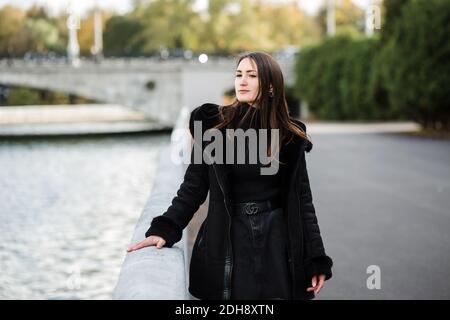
296 35 382 120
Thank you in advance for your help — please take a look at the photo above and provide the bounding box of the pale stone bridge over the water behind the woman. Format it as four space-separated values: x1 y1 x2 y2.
0 58 294 127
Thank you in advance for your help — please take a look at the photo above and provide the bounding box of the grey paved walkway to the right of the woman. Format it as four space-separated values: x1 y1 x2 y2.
191 129 450 299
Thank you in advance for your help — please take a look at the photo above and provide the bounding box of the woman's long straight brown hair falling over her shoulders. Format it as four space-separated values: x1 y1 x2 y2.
214 51 312 156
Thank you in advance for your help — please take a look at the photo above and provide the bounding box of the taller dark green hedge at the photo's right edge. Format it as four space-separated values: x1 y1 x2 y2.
381 0 450 129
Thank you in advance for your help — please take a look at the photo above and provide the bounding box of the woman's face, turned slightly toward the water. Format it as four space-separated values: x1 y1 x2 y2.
234 58 259 104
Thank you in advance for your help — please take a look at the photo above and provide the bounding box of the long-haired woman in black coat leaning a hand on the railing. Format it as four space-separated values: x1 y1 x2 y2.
128 52 332 299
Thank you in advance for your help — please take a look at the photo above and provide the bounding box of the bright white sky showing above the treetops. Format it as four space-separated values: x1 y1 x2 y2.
0 0 370 15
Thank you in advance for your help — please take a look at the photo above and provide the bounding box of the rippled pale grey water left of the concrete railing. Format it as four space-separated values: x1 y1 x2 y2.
0 134 169 299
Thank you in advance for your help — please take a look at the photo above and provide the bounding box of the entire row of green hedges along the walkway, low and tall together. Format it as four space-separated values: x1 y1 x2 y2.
295 0 450 128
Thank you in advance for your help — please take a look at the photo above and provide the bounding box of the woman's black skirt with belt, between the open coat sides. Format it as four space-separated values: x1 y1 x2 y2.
231 201 291 300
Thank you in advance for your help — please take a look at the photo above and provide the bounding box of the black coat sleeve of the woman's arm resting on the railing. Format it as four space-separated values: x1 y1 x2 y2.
145 107 209 248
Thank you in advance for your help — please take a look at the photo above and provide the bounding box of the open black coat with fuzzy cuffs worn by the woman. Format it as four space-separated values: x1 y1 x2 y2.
145 103 333 299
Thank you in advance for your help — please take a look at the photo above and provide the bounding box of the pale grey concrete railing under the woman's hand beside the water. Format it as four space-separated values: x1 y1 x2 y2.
113 107 191 300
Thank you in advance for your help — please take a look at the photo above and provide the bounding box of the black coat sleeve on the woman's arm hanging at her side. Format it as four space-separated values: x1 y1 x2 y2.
300 126 333 280
